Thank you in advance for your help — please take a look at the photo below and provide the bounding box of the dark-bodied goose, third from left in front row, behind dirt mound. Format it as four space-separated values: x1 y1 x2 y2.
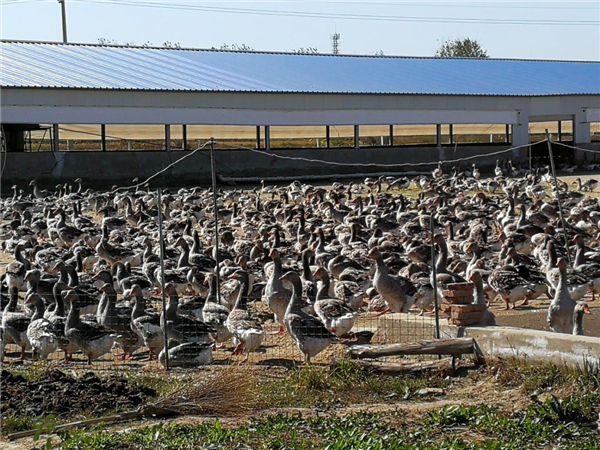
64 289 118 365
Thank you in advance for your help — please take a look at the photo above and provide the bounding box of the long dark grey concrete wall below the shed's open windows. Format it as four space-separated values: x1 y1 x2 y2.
3 146 527 190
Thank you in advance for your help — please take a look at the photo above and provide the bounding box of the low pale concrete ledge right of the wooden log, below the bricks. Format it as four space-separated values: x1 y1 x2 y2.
443 326 600 366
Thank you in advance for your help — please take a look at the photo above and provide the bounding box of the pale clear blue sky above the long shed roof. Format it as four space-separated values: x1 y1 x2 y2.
0 0 600 61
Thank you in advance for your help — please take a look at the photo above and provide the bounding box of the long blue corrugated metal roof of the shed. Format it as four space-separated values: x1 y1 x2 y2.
0 40 600 96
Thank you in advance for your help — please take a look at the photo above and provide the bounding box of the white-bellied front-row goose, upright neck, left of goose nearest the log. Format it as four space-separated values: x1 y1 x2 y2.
225 270 265 362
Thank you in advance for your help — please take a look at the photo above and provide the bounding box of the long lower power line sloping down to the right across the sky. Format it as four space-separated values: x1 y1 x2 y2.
71 0 600 26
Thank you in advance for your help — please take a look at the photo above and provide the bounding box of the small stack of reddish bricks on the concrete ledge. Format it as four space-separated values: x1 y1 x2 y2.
440 283 487 326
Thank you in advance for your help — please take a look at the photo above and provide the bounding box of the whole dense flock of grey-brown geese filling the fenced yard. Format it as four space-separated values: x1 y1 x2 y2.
0 165 600 366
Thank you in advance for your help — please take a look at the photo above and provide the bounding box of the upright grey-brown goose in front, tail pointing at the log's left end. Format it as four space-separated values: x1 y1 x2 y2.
281 272 337 364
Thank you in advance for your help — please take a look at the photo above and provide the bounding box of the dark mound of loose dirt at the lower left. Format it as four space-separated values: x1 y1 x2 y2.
0 370 156 417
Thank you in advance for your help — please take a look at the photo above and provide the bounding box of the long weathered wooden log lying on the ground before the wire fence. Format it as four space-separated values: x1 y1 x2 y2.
348 338 473 359
